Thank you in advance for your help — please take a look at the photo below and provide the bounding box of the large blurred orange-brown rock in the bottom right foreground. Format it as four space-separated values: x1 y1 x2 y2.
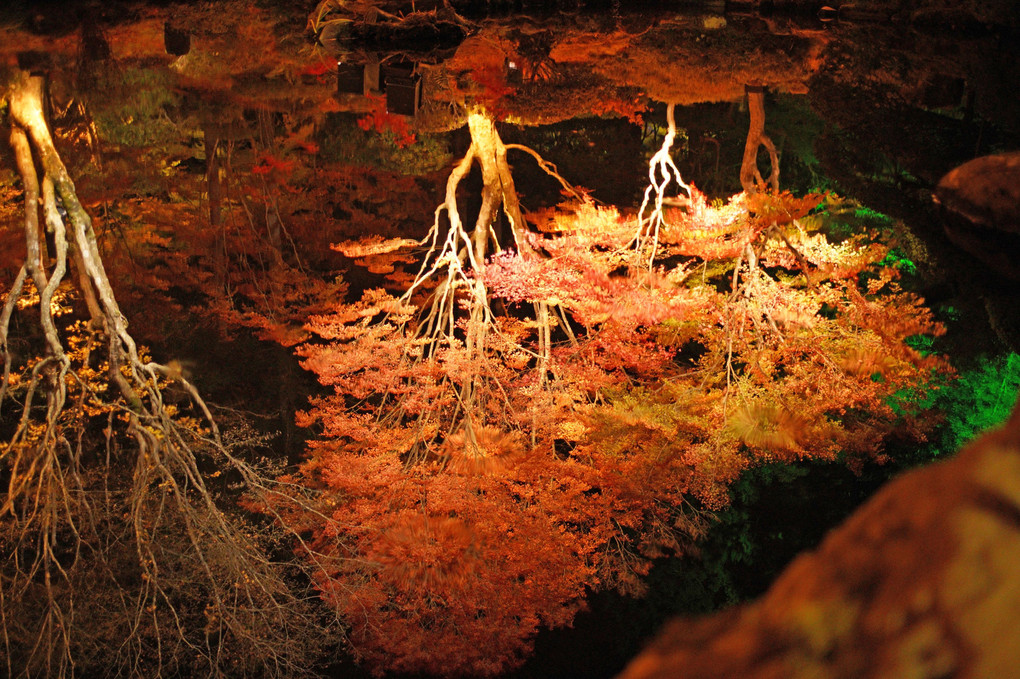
620 399 1020 679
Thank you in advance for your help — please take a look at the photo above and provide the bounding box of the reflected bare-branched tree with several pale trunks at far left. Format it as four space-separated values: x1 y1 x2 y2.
0 70 326 676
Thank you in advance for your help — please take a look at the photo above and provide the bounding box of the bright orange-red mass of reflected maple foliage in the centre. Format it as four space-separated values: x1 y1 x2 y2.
287 170 946 675
